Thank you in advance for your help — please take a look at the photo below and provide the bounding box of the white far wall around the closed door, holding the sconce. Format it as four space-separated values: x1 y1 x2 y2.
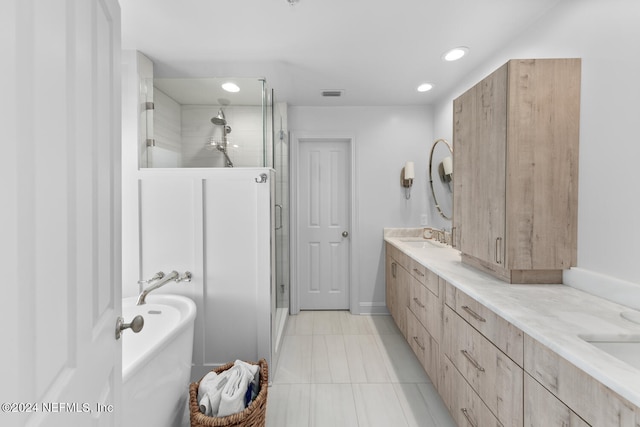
288 106 433 312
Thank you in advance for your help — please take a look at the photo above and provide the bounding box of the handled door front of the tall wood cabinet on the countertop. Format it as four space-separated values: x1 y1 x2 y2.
454 65 507 266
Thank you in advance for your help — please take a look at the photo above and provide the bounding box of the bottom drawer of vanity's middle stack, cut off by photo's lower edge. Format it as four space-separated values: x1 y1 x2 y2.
438 355 504 427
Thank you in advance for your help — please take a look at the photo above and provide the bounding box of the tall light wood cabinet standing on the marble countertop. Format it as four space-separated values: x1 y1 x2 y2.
453 59 581 283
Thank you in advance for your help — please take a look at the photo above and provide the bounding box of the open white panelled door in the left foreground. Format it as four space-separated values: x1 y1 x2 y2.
0 0 122 427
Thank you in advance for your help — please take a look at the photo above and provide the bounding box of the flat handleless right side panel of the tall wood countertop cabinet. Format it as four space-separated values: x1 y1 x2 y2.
506 59 581 272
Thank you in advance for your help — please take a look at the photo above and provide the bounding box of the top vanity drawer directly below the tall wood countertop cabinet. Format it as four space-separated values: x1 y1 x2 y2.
446 284 524 367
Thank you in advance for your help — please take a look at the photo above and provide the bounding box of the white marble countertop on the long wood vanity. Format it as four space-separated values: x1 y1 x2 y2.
384 229 640 407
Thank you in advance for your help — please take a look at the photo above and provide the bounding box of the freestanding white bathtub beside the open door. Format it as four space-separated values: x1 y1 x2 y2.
122 294 196 427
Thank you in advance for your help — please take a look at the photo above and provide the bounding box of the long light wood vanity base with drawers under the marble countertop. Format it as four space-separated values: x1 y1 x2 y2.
386 243 640 427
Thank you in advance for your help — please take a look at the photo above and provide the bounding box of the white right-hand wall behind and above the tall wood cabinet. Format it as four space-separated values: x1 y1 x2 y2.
434 0 640 308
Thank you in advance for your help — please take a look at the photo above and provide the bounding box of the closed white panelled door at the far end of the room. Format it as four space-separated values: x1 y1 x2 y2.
297 139 351 310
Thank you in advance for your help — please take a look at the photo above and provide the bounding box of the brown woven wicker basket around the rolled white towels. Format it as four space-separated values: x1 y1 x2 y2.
189 359 269 427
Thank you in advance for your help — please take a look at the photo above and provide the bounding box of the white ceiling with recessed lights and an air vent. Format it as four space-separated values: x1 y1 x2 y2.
120 0 562 106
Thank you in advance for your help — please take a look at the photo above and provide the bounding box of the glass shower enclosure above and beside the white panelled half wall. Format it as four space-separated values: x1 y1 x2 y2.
138 77 290 372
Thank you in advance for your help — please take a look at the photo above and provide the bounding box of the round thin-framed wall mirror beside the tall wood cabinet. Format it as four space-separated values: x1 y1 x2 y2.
429 138 453 220
